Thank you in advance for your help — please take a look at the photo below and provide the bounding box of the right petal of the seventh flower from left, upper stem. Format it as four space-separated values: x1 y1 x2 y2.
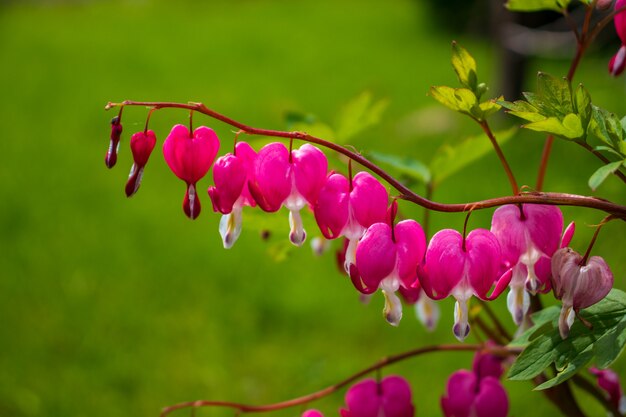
394 220 426 287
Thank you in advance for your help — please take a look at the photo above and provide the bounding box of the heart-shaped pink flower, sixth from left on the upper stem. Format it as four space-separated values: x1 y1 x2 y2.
314 171 389 273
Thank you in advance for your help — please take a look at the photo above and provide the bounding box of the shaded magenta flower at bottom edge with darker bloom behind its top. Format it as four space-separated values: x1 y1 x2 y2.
441 352 509 417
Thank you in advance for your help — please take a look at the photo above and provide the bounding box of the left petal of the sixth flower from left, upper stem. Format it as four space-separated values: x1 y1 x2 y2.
313 174 350 239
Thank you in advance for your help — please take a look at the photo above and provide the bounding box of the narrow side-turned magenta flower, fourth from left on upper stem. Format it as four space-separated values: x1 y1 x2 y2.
207 142 256 249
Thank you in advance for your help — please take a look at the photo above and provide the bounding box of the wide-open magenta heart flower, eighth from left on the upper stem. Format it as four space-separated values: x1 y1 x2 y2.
419 229 511 341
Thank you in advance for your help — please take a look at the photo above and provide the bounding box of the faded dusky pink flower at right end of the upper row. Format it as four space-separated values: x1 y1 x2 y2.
552 248 613 339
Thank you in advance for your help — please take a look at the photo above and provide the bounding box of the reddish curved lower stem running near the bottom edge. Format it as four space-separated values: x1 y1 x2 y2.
161 345 520 417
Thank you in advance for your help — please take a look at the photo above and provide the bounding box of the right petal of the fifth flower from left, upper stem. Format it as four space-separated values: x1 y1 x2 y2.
291 143 328 205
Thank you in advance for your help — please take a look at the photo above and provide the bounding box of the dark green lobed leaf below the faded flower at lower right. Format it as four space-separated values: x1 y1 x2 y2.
508 289 626 389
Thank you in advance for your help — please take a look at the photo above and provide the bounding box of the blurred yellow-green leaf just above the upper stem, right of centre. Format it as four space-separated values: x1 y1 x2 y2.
430 127 517 184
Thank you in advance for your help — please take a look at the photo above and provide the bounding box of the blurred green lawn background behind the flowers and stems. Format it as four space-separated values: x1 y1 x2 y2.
0 0 626 417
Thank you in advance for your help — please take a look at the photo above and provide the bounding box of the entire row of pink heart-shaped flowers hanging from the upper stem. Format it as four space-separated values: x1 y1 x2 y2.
105 116 613 341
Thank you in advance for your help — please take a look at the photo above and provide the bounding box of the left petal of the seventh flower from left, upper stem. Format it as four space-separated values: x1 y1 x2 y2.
356 223 396 288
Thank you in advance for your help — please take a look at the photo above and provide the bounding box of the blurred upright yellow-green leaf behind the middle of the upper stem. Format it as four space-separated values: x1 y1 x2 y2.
335 91 389 143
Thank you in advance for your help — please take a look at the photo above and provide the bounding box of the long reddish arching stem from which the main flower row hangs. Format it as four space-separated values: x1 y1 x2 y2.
105 100 626 221
